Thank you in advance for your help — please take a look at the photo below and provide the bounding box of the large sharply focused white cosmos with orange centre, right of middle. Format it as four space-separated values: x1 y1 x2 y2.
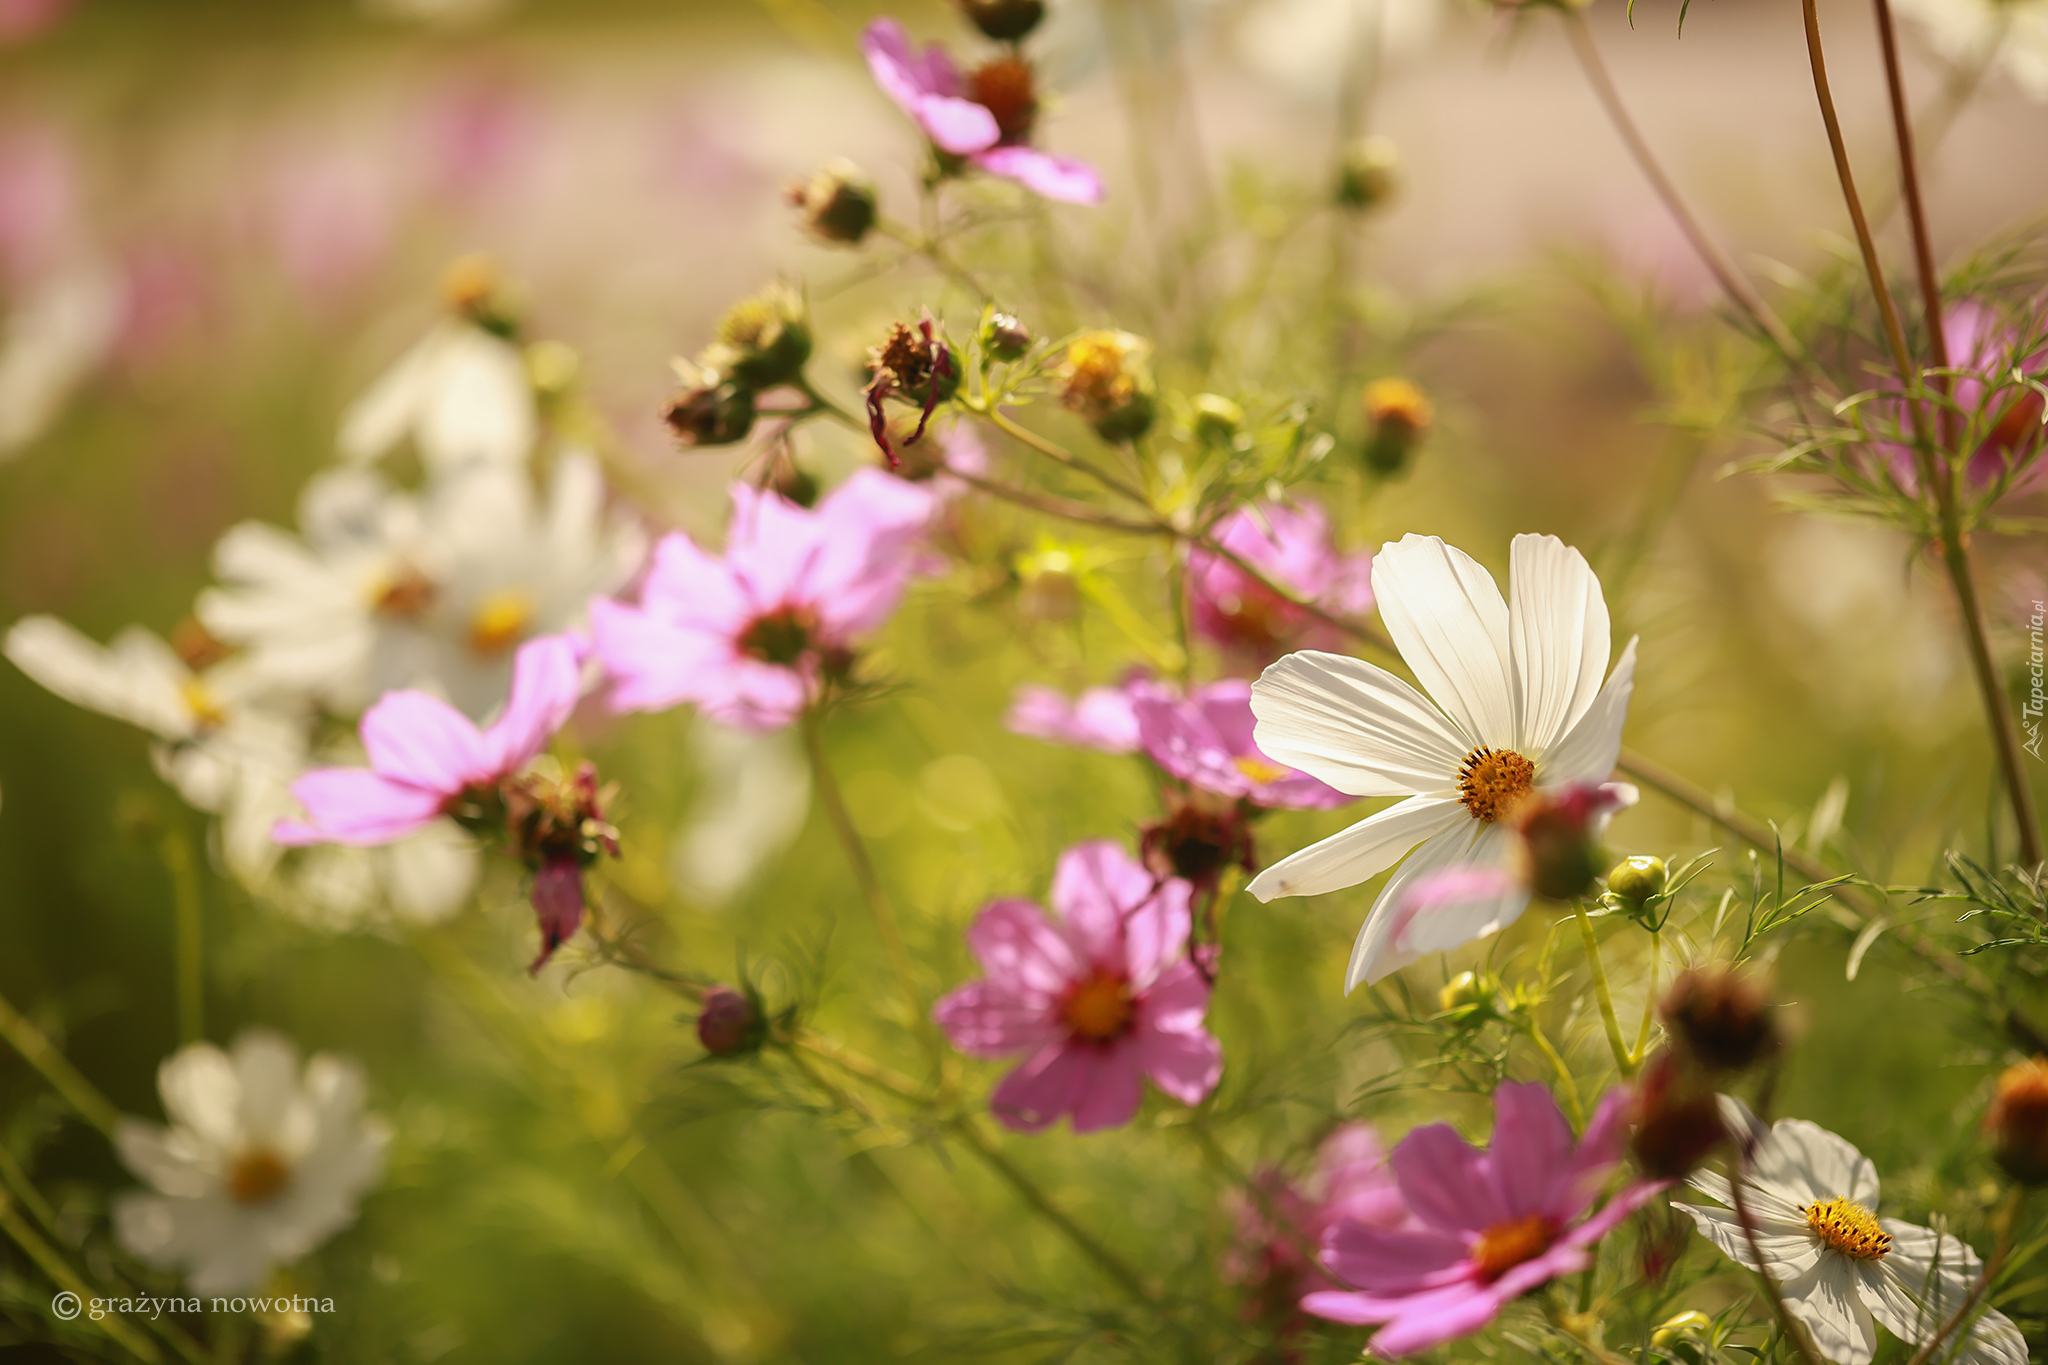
1251 536 1636 990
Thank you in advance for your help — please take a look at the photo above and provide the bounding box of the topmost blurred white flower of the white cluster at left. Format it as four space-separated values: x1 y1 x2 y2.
340 317 537 475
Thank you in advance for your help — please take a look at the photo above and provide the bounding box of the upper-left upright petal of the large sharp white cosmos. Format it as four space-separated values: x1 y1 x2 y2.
1372 534 1516 749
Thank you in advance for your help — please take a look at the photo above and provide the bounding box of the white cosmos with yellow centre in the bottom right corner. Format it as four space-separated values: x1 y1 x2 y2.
1673 1097 2028 1365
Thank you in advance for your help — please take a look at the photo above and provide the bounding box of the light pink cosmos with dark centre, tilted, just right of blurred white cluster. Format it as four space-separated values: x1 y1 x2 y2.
590 469 932 731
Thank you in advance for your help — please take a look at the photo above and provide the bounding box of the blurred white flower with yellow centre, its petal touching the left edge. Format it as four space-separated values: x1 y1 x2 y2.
0 616 305 882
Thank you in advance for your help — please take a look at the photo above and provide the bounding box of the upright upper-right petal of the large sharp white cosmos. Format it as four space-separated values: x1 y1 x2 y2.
1507 536 1612 755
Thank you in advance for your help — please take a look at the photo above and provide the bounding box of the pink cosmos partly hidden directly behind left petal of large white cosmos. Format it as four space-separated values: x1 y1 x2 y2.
1130 677 1356 810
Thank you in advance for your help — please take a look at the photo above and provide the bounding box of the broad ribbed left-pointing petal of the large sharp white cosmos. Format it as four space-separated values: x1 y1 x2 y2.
1251 651 1470 796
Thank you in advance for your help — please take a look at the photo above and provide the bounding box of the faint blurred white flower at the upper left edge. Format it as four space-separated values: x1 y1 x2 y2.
0 266 123 460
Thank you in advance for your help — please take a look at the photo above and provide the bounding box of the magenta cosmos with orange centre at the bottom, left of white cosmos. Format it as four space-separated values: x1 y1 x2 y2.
1300 1081 1665 1359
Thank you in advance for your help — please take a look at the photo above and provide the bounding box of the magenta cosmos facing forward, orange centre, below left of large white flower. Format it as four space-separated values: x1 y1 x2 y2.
932 841 1223 1132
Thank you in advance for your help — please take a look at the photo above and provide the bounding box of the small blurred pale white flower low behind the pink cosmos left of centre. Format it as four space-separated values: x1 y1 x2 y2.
674 716 811 905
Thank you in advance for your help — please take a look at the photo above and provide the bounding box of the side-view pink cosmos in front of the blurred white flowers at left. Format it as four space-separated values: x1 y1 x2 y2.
270 634 584 847
